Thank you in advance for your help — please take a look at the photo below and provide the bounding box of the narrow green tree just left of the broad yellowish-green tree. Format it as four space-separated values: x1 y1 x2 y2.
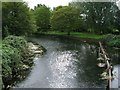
34 4 51 32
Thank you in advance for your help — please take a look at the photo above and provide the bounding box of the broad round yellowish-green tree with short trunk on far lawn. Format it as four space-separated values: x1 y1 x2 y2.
51 6 81 35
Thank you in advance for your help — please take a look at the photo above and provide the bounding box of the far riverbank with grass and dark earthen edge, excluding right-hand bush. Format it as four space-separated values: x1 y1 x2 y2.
35 31 106 44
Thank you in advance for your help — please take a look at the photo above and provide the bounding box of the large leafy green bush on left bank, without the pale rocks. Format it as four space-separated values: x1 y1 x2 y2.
2 36 30 86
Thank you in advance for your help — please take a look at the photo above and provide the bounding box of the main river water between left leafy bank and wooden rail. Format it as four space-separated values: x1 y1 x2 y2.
14 36 118 88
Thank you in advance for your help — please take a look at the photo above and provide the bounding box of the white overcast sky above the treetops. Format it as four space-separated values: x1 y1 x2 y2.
23 0 72 9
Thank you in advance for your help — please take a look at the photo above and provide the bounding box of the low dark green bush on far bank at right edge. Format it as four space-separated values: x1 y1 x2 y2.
105 34 120 48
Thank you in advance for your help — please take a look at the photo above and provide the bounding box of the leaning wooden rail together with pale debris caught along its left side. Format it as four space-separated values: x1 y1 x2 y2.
98 42 113 90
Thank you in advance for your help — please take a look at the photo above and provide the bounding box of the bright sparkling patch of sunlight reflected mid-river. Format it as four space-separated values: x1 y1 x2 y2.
50 51 76 88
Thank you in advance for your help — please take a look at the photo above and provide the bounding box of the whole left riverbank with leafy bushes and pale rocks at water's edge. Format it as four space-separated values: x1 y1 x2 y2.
2 36 45 90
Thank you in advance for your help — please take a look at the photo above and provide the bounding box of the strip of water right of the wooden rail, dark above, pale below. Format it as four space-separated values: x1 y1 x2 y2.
107 48 120 88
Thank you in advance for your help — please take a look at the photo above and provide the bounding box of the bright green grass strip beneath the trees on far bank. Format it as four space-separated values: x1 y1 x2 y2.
47 31 106 40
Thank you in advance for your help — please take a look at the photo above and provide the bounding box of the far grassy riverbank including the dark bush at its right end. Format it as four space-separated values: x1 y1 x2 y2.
42 31 120 49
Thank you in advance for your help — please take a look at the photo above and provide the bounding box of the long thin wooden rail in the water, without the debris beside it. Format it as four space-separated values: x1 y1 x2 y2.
99 42 112 90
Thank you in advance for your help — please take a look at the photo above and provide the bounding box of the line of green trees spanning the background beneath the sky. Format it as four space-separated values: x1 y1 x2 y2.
2 0 120 37
